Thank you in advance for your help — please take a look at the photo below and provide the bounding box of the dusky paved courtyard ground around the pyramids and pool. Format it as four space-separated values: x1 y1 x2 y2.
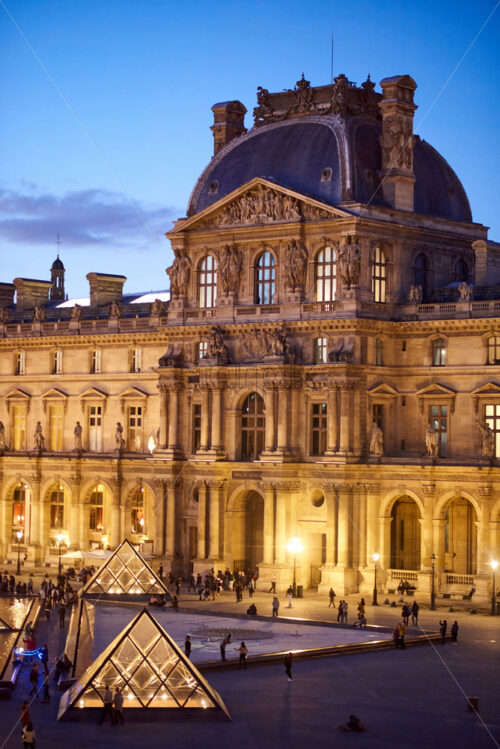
0 568 500 749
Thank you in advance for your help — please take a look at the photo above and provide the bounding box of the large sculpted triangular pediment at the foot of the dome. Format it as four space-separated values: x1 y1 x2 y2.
167 177 350 232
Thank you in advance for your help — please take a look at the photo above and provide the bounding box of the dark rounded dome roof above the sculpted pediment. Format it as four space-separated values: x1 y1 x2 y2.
188 115 472 221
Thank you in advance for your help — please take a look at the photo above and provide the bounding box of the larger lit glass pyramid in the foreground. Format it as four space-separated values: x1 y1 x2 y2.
57 608 231 720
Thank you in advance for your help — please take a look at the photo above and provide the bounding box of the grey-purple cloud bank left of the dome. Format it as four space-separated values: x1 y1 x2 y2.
0 183 181 249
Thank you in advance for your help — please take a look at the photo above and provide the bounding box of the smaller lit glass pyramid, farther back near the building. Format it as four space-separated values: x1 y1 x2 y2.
78 539 172 601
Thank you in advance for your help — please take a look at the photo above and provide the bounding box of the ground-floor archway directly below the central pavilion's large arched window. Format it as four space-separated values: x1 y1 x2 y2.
231 490 264 570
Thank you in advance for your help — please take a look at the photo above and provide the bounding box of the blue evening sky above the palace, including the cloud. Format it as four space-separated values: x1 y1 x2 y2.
0 0 500 296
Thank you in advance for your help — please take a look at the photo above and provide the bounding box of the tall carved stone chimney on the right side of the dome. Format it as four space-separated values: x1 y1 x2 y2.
379 75 417 211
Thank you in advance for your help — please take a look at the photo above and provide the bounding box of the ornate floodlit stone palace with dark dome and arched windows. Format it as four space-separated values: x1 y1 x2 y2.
0 75 500 597
